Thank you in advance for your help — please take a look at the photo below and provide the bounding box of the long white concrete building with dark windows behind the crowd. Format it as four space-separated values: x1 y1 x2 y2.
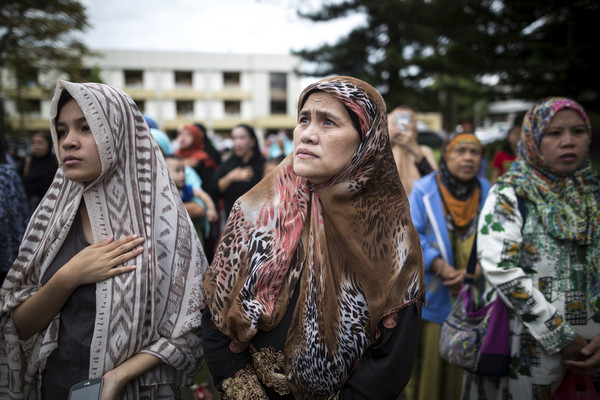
2 50 303 147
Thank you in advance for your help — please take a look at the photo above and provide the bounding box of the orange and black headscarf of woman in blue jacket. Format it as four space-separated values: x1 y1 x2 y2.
440 133 483 201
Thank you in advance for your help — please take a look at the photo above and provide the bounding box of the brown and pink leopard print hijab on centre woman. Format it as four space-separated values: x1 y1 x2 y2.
203 77 424 399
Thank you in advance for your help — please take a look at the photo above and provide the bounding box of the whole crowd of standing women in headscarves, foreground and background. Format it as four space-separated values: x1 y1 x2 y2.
0 76 600 400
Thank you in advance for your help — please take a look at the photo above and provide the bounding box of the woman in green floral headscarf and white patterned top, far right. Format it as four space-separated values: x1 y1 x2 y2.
464 97 600 399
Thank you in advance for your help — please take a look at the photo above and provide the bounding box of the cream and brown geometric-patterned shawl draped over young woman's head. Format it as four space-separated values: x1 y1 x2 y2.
0 81 207 398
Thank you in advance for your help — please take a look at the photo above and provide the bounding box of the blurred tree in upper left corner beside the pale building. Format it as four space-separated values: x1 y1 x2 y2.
0 0 91 136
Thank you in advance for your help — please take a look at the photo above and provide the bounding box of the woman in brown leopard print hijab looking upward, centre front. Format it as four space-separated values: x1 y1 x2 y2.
202 77 424 399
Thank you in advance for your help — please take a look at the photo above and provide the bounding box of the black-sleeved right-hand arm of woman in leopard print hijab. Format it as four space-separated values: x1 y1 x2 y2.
338 304 421 400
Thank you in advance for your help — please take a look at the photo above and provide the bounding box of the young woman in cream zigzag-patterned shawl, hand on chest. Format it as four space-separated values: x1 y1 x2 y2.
0 81 207 399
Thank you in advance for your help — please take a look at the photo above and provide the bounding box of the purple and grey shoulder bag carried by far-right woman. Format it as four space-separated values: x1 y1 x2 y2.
439 234 510 376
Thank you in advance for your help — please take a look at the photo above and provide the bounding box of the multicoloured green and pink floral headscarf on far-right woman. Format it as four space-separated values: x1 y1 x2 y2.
498 97 600 312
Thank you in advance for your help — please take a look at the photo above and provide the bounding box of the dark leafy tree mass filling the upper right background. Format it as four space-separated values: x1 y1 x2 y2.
296 0 600 130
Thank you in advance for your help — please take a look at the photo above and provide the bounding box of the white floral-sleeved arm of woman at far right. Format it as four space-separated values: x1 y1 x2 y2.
477 185 577 354
